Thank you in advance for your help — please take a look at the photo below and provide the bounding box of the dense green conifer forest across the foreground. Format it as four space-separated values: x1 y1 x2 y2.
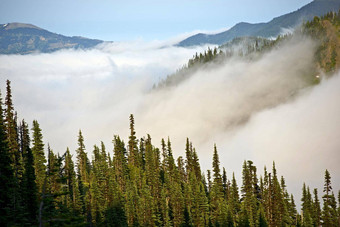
0 80 340 226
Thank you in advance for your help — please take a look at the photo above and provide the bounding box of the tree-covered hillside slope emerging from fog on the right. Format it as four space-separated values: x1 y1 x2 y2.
154 11 340 89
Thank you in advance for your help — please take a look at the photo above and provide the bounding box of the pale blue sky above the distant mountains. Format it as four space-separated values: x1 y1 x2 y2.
0 0 311 41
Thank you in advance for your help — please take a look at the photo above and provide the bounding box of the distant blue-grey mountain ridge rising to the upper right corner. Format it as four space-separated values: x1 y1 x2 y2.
177 0 340 47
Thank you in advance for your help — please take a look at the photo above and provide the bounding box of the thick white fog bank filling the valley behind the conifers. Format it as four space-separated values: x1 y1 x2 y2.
0 34 340 196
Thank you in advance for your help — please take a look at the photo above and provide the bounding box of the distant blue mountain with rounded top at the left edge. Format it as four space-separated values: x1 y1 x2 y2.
0 23 103 54
